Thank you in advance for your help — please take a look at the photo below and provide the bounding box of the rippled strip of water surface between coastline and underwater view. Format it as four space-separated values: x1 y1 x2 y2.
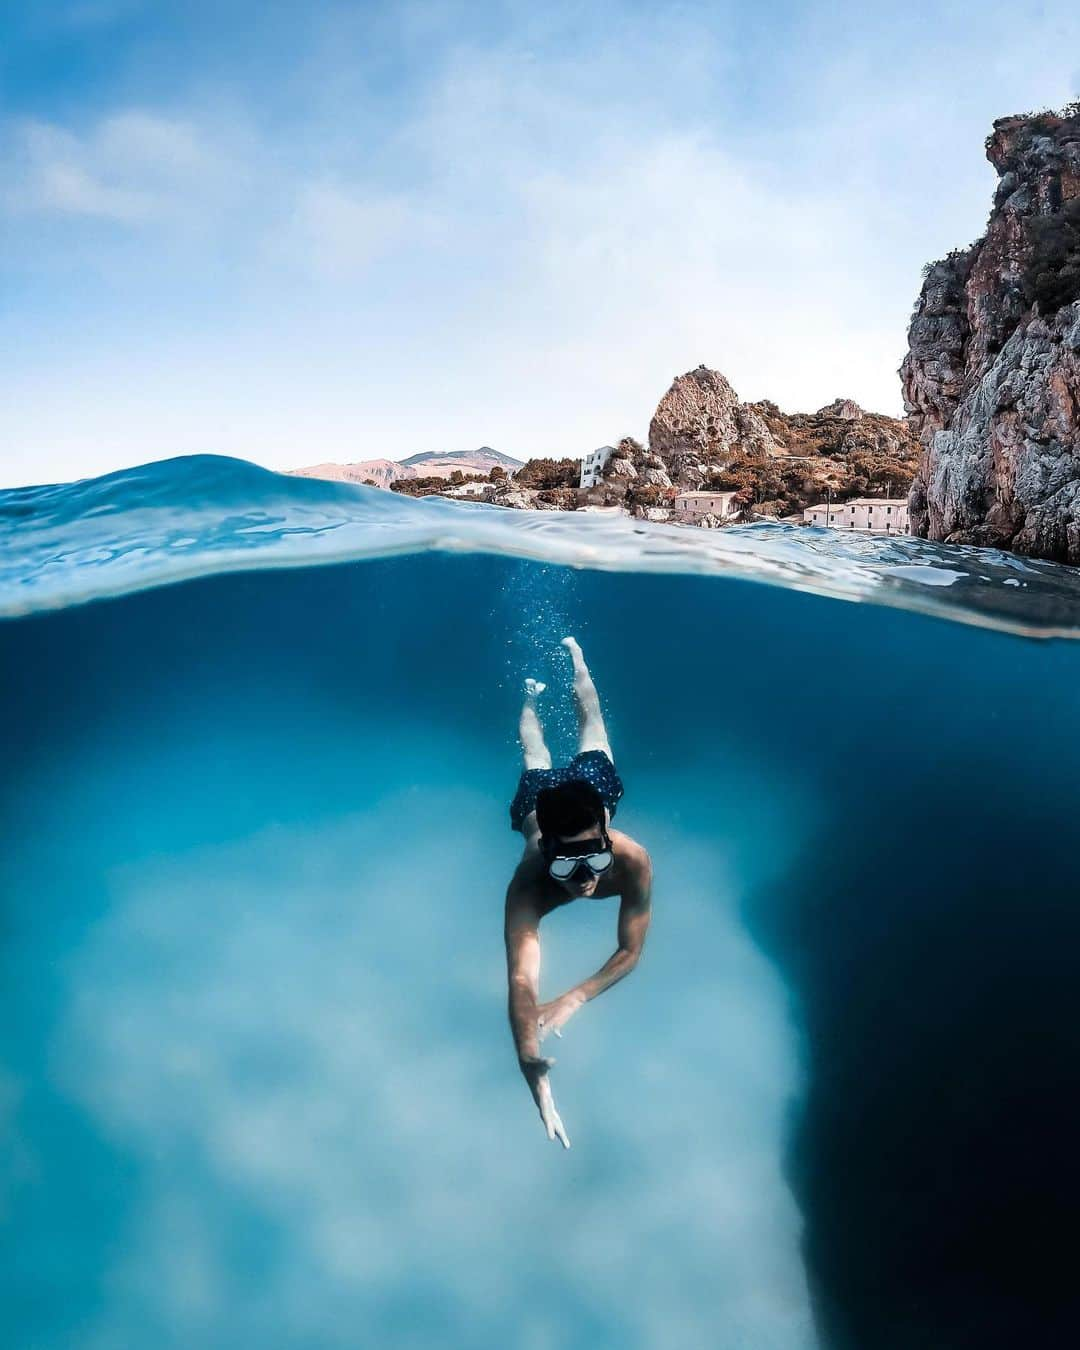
0 455 1080 637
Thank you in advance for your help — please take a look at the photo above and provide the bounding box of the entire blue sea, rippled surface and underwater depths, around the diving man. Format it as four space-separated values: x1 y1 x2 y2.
0 456 1080 1350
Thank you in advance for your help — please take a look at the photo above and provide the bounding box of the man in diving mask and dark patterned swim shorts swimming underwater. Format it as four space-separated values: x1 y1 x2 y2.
506 637 652 1149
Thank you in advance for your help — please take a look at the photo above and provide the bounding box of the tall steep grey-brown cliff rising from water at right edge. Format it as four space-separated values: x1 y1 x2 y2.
900 105 1080 563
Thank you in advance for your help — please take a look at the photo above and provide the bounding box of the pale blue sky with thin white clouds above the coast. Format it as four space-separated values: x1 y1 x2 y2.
0 0 1080 486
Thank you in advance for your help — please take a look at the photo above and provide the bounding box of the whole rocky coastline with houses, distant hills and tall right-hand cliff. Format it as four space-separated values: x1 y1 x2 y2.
294 104 1080 564
